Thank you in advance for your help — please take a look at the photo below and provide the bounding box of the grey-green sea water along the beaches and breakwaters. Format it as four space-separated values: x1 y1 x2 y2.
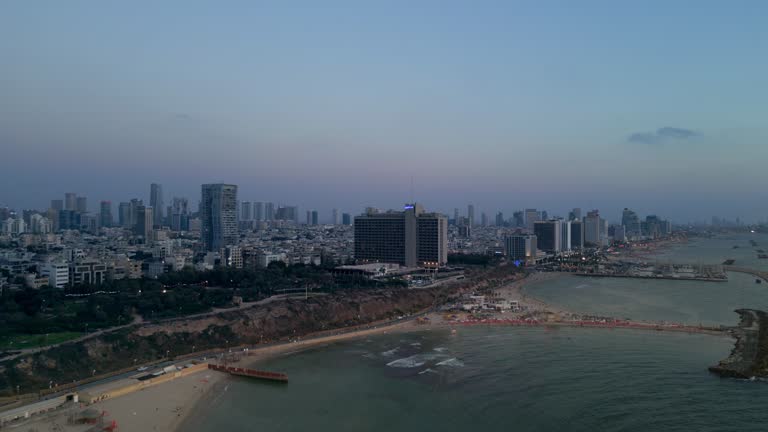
185 234 768 432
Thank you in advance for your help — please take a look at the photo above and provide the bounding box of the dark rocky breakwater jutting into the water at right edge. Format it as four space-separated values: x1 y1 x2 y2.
709 309 768 378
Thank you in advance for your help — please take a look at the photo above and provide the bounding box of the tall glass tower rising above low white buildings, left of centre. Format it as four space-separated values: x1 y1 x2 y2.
200 184 238 251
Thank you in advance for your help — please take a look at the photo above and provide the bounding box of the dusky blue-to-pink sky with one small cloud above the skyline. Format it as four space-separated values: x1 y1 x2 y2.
0 0 768 222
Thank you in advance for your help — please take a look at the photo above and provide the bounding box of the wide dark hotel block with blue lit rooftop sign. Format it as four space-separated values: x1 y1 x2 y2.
355 204 448 267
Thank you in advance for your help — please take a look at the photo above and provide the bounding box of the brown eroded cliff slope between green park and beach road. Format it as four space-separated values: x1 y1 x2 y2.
0 288 444 394
